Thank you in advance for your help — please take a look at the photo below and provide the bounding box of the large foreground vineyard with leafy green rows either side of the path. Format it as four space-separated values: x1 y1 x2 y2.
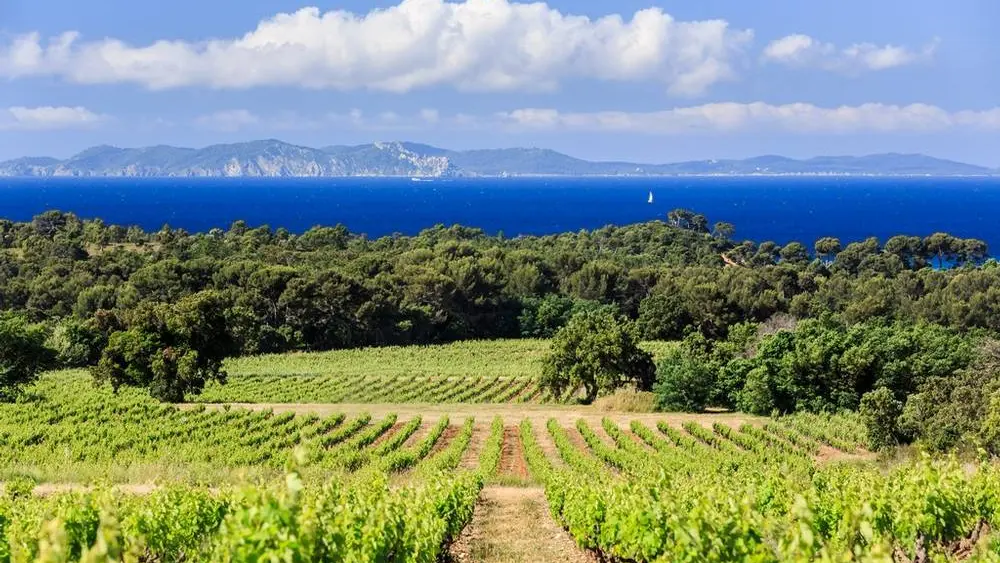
0 373 1000 563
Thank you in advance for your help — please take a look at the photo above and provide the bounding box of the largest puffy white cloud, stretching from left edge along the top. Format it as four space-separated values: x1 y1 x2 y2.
0 0 752 95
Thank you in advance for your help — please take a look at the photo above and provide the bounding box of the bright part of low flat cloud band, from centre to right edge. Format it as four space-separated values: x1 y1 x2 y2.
495 102 1000 135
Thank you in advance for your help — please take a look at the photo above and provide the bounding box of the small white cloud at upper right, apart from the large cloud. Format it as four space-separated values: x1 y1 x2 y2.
762 34 938 73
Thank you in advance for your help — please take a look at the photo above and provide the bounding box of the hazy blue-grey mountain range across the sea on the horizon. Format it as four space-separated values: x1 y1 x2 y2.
0 140 1000 177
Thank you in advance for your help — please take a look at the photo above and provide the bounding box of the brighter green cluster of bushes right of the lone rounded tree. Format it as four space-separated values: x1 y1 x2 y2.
654 316 1000 454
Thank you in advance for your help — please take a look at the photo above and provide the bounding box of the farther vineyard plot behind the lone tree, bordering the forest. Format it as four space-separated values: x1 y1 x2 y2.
195 339 670 404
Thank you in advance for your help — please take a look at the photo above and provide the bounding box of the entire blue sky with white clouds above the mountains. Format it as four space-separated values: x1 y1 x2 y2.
0 0 1000 167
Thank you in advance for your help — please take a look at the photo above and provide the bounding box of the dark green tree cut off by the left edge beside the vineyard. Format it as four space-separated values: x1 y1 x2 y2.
0 313 53 401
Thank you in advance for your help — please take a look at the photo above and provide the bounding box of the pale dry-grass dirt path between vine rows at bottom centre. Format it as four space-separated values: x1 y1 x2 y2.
450 487 597 563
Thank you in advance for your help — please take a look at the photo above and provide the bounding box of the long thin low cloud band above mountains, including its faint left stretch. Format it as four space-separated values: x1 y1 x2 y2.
184 102 1000 136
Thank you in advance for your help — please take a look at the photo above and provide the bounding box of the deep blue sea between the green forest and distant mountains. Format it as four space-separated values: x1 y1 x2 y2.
0 177 1000 250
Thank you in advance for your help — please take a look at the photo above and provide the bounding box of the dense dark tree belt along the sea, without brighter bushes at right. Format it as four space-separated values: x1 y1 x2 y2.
0 210 1000 404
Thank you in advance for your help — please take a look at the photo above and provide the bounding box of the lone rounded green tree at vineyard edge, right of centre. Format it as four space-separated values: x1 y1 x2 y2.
542 310 656 403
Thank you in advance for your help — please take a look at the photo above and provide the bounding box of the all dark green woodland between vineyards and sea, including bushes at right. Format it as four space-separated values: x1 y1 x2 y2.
0 209 1000 443
